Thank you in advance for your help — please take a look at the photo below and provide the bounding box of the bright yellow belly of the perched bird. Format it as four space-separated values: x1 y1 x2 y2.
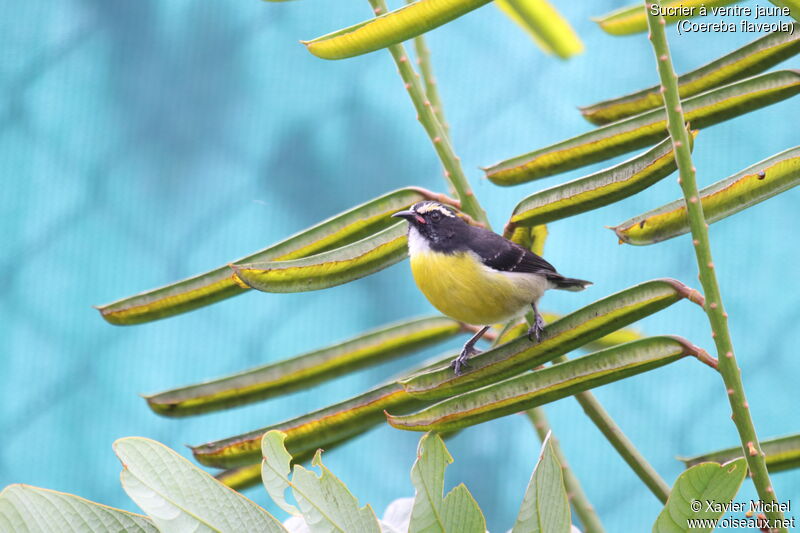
411 252 547 326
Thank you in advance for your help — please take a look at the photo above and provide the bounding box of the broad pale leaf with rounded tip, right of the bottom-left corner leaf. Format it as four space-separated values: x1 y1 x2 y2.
114 437 286 533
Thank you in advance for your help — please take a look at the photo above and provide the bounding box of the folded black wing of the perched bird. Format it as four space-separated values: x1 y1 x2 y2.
462 226 556 274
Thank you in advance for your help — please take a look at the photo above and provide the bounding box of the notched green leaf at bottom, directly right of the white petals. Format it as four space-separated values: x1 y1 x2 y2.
408 434 486 533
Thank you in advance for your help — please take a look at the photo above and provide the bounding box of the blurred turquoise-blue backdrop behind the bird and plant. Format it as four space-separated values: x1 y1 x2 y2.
0 0 800 532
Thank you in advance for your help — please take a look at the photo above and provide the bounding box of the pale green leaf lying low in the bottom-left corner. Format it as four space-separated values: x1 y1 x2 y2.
0 485 158 533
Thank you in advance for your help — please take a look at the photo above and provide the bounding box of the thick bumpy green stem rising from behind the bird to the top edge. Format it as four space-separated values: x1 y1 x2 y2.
369 0 489 227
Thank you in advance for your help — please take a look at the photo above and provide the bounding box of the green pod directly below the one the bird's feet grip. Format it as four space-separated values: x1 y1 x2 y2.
387 337 699 431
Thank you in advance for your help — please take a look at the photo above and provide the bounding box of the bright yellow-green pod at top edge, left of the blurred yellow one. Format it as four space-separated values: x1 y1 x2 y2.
303 0 489 59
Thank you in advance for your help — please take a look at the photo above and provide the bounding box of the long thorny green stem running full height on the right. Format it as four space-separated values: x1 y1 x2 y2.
645 0 787 531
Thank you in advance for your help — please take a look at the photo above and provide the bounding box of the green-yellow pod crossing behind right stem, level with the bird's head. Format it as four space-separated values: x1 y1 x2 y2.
611 146 800 245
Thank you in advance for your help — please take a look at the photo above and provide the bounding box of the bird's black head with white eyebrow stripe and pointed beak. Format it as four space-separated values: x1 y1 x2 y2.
392 201 469 252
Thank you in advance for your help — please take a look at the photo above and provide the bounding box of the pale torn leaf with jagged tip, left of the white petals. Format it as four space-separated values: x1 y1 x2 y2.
292 451 381 533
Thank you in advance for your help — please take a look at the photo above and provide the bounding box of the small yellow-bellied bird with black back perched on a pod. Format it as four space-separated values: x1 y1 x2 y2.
392 201 592 375
